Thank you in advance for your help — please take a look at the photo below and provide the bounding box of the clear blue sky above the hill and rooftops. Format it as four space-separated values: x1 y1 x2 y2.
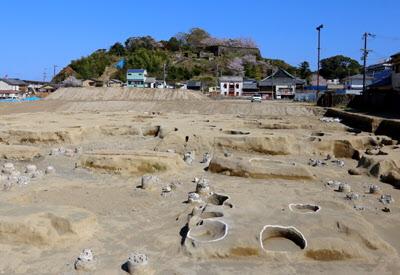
0 0 400 81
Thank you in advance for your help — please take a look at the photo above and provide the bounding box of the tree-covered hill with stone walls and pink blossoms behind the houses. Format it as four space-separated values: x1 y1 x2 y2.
53 28 298 86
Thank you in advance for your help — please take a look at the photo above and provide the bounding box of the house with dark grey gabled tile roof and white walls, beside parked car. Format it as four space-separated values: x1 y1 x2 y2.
258 69 306 99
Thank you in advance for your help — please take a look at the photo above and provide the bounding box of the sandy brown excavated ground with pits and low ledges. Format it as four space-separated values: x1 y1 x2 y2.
0 99 400 274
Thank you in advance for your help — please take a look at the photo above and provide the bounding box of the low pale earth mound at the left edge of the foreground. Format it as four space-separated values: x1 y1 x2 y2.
0 203 97 244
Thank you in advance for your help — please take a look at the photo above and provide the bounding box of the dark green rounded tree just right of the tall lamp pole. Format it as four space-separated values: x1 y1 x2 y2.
319 55 362 79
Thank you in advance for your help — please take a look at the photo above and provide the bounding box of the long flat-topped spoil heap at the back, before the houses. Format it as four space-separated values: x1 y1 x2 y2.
45 87 207 101
